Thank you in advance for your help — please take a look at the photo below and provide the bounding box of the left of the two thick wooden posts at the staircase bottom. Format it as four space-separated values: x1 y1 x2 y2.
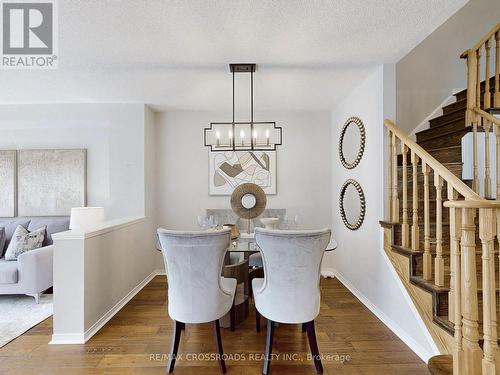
460 208 483 375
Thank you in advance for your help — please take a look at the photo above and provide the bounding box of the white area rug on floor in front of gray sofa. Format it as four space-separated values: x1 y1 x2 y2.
0 294 53 348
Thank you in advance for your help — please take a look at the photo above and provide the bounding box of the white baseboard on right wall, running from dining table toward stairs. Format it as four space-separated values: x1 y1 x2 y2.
334 270 439 363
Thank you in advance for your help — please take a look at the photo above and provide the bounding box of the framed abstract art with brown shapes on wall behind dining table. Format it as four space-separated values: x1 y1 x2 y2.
208 151 276 195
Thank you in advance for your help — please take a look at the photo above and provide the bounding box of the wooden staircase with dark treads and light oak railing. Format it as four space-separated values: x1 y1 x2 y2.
380 24 500 375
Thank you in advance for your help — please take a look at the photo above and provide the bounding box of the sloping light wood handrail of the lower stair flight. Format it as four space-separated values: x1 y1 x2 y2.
384 119 481 200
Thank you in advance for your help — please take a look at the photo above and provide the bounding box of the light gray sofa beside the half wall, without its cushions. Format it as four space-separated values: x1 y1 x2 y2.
0 216 69 303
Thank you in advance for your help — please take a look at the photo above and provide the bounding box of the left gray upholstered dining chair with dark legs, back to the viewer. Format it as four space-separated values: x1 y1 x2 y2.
158 229 236 373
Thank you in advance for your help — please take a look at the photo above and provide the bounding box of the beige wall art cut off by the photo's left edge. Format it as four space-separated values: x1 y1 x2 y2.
0 150 17 217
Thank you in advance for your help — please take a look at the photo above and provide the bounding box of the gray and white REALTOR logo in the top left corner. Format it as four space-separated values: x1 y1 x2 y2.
1 0 57 69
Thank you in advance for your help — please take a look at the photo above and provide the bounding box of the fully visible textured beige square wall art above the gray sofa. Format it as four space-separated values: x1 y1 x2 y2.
17 149 87 216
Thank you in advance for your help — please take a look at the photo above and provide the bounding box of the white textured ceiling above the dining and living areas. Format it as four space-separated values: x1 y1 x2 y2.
0 0 467 109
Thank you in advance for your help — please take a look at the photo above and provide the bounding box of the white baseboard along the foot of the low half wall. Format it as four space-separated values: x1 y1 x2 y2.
49 270 165 345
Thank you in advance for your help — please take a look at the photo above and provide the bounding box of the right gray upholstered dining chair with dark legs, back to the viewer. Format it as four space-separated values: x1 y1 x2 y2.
252 228 331 375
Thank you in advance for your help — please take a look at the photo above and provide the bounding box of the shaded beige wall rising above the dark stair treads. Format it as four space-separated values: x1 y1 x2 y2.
396 0 500 133
